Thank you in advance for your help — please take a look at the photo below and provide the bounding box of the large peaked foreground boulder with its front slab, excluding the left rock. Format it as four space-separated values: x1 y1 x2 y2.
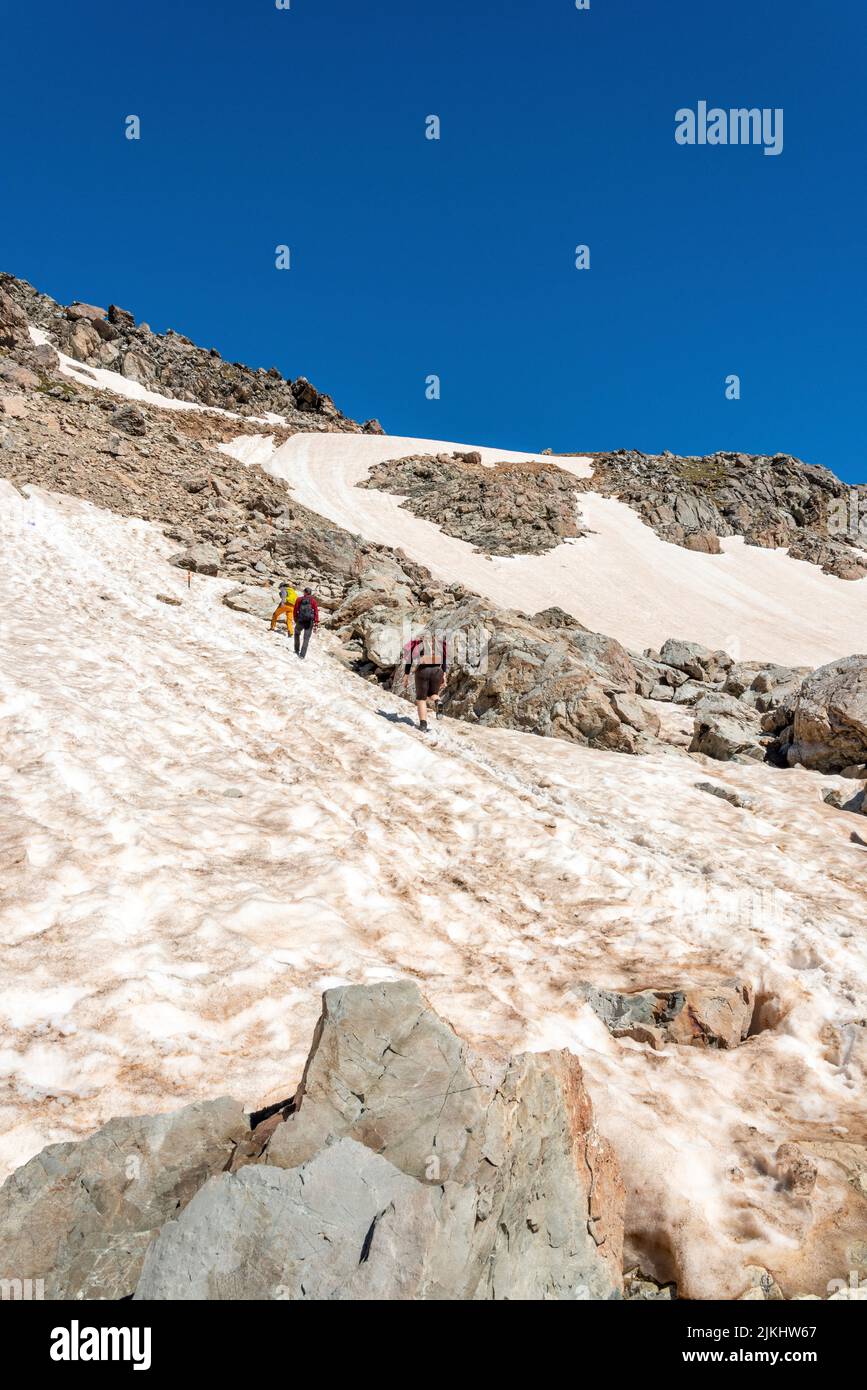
148 981 624 1300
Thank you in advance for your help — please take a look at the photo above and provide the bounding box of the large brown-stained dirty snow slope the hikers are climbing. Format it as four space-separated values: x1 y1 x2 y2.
0 480 867 1297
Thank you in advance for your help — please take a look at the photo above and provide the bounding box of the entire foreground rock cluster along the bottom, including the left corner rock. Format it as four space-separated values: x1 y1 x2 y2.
0 981 624 1300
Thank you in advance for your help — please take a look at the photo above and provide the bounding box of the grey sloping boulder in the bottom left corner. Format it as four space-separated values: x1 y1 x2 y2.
0 1098 249 1300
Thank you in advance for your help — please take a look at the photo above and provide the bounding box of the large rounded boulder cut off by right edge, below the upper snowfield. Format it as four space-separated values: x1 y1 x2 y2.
788 656 867 773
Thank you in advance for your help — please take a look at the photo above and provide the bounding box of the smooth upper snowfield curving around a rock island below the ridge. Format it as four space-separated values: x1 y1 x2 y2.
252 434 867 666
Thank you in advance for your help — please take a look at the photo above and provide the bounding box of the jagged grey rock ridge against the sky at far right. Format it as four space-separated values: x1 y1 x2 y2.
578 449 867 580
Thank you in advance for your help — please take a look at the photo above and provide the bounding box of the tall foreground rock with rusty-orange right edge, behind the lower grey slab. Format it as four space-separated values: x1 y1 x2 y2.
240 981 622 1298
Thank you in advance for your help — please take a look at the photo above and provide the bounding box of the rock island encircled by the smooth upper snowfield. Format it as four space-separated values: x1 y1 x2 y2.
358 452 585 555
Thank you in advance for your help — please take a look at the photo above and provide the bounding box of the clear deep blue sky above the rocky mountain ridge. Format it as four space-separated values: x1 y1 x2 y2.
0 0 867 481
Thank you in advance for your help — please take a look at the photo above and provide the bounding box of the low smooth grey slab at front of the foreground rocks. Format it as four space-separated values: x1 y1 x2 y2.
135 1138 475 1302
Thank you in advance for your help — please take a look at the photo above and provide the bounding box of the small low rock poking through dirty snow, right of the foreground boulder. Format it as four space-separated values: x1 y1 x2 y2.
574 980 754 1051
